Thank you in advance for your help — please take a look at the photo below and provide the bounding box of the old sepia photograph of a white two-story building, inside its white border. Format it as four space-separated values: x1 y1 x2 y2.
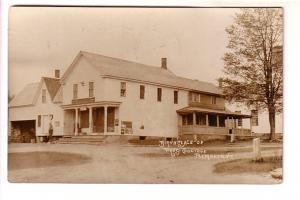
7 6 285 184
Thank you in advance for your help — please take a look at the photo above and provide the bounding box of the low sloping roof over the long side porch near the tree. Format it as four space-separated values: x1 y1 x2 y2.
176 106 251 118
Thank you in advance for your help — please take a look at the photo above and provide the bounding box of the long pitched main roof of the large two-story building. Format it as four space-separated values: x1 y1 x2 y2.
62 51 222 95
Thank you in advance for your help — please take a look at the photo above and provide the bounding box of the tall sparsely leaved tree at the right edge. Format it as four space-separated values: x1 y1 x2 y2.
219 8 283 140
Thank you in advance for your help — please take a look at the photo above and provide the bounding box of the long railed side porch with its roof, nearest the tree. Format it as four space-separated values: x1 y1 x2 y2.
177 107 251 136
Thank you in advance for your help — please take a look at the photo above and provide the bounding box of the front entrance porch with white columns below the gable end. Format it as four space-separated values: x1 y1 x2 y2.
63 102 119 136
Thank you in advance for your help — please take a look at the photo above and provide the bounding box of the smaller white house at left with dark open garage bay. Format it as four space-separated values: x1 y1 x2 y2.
8 70 63 142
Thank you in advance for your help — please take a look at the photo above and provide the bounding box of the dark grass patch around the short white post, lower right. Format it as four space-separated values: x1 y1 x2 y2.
214 157 282 174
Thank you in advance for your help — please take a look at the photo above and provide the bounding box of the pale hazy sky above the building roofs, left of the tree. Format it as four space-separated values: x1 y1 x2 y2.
9 7 238 94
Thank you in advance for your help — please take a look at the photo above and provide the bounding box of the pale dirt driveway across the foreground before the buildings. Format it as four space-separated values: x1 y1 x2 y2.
8 141 277 184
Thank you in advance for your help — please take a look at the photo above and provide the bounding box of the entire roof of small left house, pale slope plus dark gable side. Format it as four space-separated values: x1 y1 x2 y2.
9 77 60 107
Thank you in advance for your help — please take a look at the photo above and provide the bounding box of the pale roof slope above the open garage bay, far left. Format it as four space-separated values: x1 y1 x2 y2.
9 82 40 107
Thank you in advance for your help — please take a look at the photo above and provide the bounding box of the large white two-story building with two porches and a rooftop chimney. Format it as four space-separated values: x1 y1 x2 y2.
8 51 250 142
